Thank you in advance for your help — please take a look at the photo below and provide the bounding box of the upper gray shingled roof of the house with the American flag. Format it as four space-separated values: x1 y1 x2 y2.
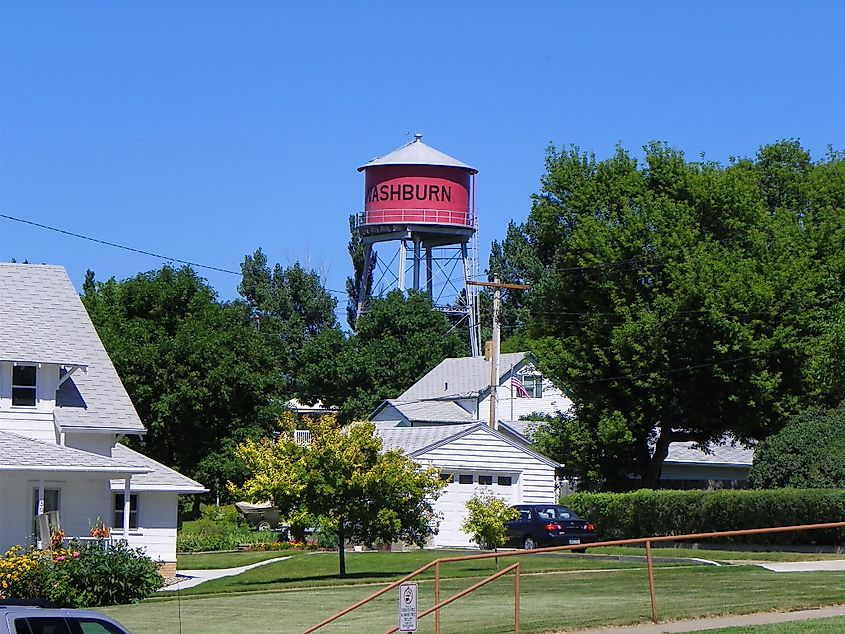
398 352 528 401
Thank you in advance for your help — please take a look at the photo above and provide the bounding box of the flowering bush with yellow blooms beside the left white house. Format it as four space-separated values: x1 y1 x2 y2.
0 542 164 608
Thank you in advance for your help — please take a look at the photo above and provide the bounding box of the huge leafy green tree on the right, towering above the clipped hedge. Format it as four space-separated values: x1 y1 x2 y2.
491 141 845 488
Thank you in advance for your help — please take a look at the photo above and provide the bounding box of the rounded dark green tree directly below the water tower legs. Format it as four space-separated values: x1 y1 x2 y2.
299 291 465 421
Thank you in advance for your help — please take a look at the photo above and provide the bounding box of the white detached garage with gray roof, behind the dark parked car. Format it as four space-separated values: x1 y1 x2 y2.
376 422 558 548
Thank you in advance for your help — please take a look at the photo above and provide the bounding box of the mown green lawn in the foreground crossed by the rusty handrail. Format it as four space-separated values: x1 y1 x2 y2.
103 551 845 634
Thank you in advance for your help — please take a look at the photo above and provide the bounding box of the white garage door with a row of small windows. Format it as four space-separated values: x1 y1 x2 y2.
434 471 520 547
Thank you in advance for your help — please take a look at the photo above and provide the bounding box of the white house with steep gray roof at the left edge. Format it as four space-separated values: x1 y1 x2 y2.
0 264 206 574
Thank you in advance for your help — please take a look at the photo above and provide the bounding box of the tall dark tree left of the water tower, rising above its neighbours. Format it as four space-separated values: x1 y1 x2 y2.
238 249 337 393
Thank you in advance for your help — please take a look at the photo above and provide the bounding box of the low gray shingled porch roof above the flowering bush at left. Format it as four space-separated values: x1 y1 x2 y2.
0 431 149 474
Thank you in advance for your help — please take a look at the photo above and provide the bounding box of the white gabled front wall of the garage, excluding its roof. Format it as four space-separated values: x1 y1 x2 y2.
415 430 555 546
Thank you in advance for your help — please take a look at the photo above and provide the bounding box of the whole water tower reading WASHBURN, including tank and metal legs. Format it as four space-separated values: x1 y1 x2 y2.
357 134 481 356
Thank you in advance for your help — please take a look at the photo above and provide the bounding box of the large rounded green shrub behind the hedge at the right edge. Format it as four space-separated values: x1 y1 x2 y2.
748 408 845 489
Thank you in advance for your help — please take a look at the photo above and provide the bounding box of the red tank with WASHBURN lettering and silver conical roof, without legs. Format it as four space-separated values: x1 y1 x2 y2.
358 134 478 228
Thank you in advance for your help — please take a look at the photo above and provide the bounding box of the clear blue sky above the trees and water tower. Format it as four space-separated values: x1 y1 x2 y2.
0 0 845 320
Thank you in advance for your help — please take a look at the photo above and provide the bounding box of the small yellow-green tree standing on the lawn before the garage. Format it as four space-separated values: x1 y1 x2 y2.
234 416 445 577
